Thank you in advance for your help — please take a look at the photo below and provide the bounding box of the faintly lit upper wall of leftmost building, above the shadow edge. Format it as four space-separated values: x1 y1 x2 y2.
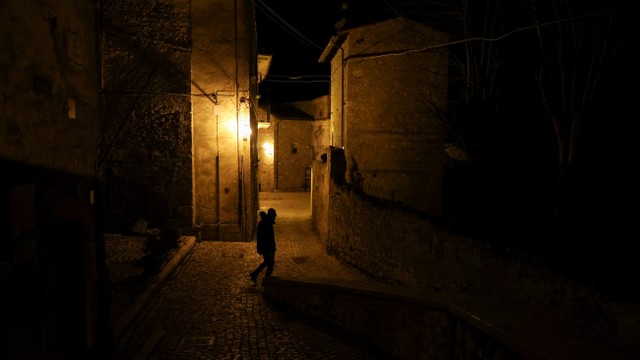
0 0 99 178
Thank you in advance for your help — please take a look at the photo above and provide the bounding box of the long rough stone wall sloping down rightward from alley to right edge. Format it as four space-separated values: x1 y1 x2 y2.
312 149 640 353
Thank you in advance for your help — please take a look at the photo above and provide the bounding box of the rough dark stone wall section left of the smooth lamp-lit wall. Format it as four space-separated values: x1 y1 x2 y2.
99 0 193 232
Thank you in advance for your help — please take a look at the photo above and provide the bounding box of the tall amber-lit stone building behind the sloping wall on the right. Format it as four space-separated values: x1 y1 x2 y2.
320 18 448 216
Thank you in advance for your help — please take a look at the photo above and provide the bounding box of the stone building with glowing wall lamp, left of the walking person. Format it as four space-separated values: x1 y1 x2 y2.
98 0 266 239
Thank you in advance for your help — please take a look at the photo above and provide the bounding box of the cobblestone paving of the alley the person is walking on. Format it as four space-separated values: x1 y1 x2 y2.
107 192 383 359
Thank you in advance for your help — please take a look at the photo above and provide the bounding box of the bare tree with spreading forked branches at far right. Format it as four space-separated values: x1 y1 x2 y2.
525 0 624 221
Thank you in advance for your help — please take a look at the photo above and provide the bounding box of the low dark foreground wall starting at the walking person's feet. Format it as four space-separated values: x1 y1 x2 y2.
263 277 532 360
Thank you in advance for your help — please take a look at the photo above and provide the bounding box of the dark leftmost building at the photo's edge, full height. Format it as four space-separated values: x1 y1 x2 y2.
0 0 108 359
